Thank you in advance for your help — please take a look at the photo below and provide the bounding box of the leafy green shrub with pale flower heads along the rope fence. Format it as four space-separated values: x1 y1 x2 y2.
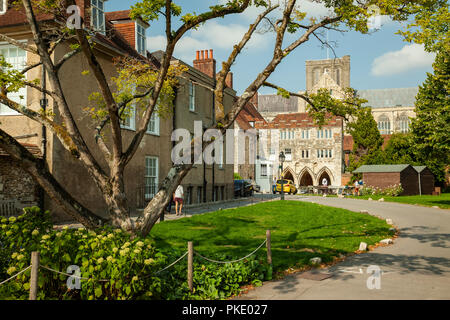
0 208 265 300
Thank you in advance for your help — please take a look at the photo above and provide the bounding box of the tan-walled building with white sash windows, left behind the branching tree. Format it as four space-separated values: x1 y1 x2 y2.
0 0 235 221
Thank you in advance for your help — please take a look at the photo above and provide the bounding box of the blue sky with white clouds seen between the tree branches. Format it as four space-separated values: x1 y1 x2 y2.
105 0 435 94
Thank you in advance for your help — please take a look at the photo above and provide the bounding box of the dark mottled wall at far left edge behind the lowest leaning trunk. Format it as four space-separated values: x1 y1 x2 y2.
0 157 39 215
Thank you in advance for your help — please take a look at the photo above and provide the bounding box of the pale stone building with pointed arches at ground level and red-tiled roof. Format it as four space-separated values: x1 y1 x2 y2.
257 113 343 192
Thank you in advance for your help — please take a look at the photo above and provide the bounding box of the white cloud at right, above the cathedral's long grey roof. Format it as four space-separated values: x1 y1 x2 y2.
371 44 435 77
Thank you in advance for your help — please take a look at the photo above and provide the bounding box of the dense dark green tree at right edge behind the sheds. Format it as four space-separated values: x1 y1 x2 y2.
411 49 450 184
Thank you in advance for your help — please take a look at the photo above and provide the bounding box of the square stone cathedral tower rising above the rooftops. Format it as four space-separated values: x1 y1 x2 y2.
306 55 350 92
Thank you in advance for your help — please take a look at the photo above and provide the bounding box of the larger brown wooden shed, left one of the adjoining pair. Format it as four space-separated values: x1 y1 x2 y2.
353 164 419 195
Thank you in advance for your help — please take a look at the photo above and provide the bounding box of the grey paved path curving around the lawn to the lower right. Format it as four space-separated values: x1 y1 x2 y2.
238 197 450 300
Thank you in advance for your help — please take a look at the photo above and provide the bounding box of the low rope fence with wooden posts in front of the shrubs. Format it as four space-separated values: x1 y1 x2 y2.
0 230 272 300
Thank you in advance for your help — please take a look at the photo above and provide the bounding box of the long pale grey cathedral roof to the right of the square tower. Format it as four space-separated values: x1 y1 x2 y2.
358 87 419 109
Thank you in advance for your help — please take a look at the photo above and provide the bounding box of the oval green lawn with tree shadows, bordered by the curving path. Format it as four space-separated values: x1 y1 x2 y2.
150 201 390 271
